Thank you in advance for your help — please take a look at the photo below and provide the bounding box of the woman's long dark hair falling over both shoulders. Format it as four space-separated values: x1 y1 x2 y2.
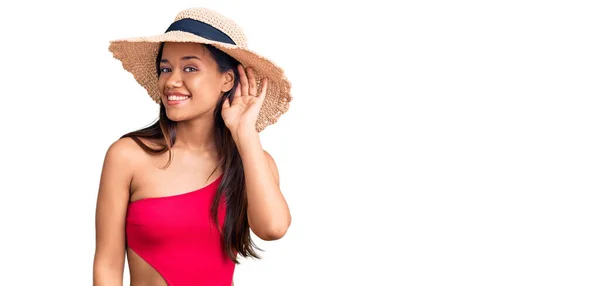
121 43 261 264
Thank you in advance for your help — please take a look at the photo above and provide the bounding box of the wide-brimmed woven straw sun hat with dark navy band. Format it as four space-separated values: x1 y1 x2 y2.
109 8 292 132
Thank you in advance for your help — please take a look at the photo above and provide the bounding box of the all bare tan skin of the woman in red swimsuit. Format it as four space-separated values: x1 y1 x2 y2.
93 43 291 286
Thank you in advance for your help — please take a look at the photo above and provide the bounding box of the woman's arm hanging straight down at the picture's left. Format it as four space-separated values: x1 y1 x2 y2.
93 138 135 286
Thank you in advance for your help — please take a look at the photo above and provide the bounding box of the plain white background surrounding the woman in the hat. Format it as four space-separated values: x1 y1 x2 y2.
0 0 600 286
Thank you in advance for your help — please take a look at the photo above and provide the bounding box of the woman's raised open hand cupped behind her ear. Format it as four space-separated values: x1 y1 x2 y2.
221 65 268 138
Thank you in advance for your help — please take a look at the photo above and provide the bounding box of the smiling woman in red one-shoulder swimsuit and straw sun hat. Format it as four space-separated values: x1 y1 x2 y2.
93 9 291 286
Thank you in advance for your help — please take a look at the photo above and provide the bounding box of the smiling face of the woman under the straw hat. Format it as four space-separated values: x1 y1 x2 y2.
158 42 234 121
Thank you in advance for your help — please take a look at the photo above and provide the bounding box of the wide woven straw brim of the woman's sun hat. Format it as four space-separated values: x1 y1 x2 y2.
109 31 292 132
